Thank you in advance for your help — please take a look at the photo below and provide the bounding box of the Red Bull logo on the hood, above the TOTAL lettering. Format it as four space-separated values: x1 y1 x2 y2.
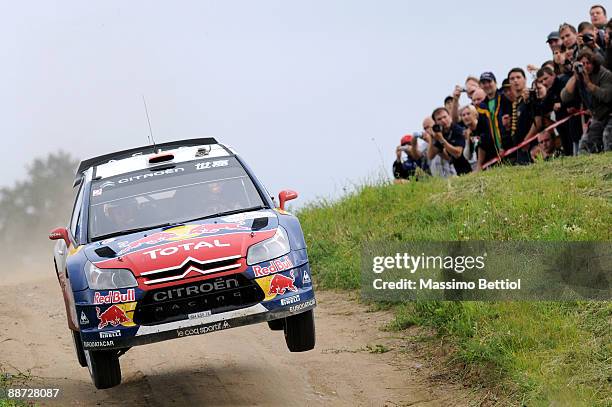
118 222 251 255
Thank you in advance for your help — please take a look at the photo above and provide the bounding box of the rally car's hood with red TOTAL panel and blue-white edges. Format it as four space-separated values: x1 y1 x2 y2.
84 210 278 277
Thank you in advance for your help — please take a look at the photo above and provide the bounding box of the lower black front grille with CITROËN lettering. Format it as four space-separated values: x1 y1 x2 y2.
134 274 265 325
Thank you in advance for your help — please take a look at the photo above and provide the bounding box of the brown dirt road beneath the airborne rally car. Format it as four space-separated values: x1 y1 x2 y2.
0 272 473 406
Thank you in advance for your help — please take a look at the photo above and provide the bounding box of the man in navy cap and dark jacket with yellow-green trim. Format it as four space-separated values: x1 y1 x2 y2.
477 72 514 156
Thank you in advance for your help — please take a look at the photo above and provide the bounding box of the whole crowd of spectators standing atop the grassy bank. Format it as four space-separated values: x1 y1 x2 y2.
393 5 612 180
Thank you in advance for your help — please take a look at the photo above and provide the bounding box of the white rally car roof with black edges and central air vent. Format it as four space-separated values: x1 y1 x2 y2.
75 138 234 185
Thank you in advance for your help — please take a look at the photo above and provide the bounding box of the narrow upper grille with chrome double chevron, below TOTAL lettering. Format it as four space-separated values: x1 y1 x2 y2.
140 255 241 286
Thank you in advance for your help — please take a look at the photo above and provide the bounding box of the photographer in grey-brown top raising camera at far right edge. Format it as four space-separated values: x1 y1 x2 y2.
561 48 612 154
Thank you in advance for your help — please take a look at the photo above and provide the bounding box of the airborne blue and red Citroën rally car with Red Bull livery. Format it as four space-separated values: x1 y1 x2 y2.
49 138 316 388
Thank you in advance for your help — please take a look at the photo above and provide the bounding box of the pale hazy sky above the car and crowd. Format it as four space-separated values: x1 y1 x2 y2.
0 0 591 207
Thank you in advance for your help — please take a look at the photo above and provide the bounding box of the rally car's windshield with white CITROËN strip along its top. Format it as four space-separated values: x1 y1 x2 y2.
89 157 264 241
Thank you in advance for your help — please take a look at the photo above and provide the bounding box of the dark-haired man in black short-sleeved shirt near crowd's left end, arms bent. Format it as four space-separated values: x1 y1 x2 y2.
427 107 472 175
